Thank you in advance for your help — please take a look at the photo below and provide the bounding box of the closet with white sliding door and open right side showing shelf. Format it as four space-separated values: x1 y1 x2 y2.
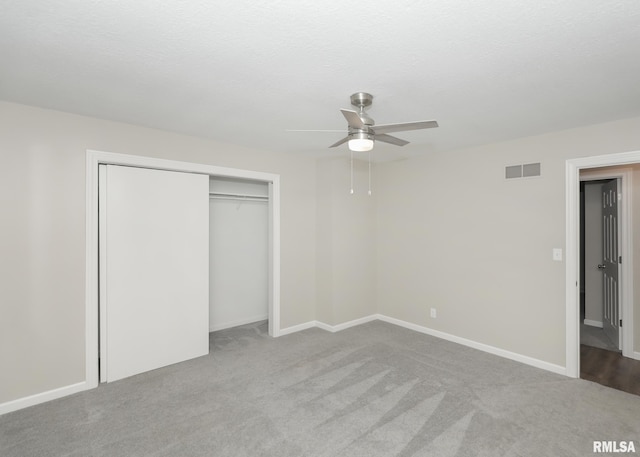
98 165 270 382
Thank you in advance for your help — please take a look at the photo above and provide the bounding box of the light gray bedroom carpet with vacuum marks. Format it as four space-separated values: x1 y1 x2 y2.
0 322 640 457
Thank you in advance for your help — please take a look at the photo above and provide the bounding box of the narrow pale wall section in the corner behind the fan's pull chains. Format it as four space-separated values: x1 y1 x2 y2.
316 154 377 325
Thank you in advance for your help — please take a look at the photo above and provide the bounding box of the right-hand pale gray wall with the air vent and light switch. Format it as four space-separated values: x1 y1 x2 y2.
376 118 640 366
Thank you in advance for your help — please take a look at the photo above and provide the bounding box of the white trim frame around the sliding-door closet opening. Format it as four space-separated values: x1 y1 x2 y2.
85 149 280 388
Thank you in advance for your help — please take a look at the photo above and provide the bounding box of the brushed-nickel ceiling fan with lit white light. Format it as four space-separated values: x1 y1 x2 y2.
329 92 438 152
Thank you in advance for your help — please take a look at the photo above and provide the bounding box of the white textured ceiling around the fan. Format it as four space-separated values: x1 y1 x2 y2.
0 0 640 160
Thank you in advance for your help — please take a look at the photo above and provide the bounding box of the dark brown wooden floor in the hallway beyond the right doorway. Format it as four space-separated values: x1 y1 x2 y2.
580 344 640 395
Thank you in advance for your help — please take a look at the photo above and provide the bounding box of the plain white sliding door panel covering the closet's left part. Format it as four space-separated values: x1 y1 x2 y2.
99 165 209 382
